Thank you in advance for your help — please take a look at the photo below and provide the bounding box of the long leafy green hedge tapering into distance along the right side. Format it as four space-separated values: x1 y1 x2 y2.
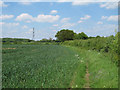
63 34 120 65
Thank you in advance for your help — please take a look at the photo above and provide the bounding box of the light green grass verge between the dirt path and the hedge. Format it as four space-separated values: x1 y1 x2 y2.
65 47 118 88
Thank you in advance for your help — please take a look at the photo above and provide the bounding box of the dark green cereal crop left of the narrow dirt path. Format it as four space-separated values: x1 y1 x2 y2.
2 45 85 88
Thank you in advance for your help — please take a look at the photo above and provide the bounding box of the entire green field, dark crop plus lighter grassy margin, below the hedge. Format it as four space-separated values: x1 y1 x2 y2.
2 45 118 88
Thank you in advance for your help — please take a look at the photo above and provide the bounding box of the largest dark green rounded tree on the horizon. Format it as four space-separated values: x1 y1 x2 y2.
55 29 74 41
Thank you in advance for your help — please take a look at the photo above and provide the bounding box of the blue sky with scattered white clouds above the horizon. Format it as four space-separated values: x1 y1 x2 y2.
0 2 118 40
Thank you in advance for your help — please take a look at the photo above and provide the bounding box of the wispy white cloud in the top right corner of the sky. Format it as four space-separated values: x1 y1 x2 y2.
100 2 118 9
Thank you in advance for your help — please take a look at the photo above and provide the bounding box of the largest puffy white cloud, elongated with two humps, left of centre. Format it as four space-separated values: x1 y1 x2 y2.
16 13 60 23
